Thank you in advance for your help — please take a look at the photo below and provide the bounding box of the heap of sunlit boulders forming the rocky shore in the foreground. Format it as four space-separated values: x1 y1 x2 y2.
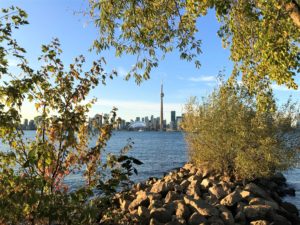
100 163 300 225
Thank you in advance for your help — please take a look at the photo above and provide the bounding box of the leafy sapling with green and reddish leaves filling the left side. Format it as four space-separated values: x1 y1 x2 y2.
0 7 141 225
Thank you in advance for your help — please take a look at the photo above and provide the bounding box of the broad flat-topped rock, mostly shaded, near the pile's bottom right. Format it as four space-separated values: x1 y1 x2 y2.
244 205 273 220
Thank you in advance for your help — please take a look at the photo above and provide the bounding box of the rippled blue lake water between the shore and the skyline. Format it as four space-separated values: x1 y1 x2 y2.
0 131 300 209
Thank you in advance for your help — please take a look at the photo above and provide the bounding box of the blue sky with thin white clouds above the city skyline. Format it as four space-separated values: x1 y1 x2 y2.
0 0 299 121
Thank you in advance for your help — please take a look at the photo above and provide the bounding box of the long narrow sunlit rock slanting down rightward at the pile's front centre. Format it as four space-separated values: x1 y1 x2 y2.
184 196 219 216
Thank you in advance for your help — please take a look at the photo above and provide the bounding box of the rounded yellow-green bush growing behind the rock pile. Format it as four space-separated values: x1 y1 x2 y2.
182 82 297 179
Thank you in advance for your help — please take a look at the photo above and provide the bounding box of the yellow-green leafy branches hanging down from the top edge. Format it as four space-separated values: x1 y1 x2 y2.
90 0 300 93
